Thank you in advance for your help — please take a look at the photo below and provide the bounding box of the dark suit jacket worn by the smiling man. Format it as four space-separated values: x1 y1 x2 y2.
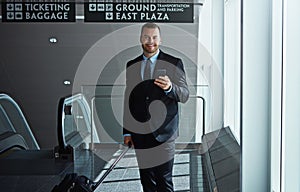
123 51 189 142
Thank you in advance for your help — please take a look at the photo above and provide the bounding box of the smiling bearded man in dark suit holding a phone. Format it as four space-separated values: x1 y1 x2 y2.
123 23 189 192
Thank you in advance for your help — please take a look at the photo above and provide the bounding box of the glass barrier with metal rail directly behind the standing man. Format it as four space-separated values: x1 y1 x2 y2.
82 85 211 148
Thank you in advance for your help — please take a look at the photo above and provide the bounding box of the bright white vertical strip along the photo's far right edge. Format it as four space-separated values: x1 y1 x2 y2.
282 0 300 192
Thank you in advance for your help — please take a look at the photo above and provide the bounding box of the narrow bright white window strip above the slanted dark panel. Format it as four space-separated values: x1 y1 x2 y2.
224 0 241 143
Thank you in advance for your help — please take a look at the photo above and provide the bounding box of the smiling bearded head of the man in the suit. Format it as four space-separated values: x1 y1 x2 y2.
140 27 161 58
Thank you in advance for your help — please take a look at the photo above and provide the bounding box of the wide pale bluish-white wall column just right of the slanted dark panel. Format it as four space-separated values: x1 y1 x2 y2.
241 0 272 192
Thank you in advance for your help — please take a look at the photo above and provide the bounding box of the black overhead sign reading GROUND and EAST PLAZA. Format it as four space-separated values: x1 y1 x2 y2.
84 1 194 23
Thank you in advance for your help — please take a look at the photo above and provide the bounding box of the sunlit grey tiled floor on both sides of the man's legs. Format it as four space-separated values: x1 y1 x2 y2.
96 150 205 192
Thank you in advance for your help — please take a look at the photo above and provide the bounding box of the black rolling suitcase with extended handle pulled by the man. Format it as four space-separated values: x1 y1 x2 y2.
52 147 130 192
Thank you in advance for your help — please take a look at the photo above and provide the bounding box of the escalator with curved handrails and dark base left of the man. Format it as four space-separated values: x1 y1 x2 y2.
0 94 122 192
